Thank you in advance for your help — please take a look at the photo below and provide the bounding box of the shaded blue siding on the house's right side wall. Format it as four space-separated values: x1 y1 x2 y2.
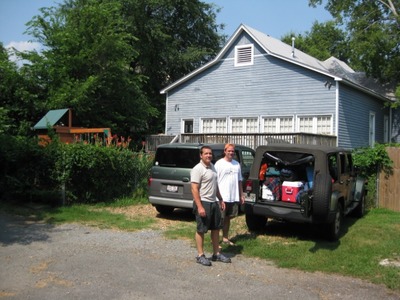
338 84 389 148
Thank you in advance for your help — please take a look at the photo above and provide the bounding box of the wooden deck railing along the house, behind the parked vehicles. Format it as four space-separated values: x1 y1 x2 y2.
146 133 336 152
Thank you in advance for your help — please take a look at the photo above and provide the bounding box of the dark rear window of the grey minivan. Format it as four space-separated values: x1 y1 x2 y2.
154 148 200 168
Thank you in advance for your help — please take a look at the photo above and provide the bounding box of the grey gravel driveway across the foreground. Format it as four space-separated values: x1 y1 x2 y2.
0 213 400 300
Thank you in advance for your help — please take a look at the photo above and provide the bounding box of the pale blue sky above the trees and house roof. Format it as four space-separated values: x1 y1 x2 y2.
0 0 331 51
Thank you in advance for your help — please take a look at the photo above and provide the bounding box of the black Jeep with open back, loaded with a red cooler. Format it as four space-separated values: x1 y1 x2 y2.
245 144 366 240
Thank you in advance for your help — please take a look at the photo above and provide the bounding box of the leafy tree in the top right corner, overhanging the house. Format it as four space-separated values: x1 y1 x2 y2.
309 0 400 101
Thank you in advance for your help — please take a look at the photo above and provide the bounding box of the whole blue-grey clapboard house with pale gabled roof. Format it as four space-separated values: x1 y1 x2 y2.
161 25 390 148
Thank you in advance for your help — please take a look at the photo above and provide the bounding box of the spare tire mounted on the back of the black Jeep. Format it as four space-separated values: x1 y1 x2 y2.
313 174 332 218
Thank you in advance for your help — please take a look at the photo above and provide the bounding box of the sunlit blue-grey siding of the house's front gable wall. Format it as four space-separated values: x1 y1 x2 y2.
166 35 336 134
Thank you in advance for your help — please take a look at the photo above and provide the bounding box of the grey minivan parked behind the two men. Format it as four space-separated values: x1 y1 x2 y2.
148 143 255 214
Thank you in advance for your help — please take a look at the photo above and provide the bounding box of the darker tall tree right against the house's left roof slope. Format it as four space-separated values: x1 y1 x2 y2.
123 0 225 132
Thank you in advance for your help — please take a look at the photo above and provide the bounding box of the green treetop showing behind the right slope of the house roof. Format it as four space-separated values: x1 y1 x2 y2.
282 21 349 62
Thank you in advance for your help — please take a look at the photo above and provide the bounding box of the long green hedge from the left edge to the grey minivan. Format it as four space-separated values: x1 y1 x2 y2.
0 136 152 204
